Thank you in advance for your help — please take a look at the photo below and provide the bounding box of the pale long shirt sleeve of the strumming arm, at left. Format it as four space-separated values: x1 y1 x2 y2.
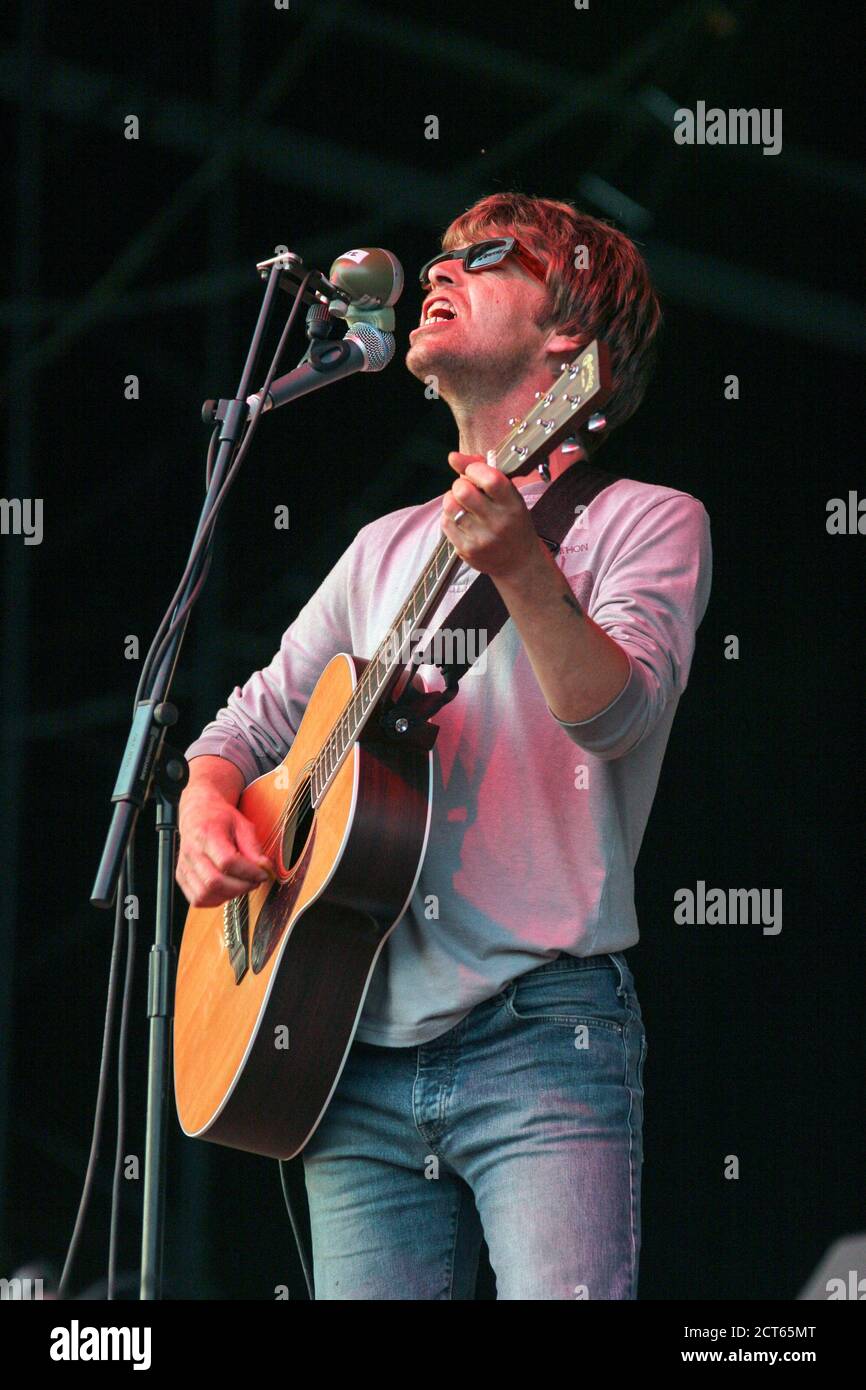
185 532 360 785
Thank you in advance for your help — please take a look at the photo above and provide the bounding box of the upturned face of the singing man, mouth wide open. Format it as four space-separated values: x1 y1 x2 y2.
406 229 550 406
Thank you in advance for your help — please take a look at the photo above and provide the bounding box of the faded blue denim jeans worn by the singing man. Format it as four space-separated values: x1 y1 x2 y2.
303 952 646 1300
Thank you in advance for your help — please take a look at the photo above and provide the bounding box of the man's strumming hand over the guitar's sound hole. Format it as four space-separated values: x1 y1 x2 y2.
175 790 277 908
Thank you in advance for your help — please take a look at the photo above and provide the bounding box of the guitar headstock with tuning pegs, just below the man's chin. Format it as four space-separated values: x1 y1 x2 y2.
495 339 610 474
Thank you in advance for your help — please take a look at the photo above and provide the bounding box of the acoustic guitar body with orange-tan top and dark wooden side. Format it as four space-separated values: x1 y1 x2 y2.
174 653 432 1158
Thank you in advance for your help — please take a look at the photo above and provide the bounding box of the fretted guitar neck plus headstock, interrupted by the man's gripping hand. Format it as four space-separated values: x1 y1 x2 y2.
310 342 610 806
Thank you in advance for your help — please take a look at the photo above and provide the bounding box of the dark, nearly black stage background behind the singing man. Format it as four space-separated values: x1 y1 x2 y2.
0 0 866 1300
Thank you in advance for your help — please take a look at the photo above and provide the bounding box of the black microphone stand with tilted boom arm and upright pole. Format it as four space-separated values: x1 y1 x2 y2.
90 260 322 1300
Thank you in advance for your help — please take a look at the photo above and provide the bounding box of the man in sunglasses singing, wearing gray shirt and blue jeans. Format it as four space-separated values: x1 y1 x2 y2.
178 193 710 1300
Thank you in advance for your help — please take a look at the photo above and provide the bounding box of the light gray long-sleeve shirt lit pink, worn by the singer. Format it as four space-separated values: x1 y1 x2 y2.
186 478 712 1047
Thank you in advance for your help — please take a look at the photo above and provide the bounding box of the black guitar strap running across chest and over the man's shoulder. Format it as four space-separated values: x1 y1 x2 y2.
379 457 617 738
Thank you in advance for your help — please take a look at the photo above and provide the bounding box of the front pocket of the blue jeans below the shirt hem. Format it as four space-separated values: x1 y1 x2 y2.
507 963 628 1036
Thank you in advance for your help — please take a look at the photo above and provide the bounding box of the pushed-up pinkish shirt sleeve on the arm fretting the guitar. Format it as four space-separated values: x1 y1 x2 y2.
548 492 712 759
